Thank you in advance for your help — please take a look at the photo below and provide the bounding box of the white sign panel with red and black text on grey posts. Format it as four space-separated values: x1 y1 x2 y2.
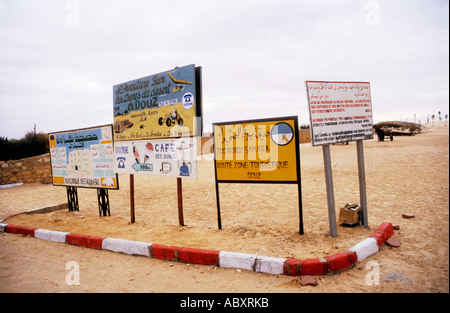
306 81 373 146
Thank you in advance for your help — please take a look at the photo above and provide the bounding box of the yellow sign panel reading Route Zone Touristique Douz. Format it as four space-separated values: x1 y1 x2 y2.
213 116 299 183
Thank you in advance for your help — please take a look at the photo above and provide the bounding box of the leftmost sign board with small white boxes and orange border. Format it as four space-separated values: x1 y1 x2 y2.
49 125 119 189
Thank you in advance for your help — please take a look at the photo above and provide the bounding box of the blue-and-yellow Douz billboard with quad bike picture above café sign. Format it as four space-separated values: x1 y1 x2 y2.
113 64 202 142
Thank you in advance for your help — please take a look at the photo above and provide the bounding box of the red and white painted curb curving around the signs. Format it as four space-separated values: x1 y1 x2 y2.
0 205 394 276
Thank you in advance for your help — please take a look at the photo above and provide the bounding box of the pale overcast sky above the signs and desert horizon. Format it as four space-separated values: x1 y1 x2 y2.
0 0 449 139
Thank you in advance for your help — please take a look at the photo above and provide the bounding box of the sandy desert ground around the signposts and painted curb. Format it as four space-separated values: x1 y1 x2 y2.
0 120 449 293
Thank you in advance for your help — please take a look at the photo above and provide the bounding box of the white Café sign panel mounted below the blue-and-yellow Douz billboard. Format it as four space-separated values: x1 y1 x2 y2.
114 137 197 178
